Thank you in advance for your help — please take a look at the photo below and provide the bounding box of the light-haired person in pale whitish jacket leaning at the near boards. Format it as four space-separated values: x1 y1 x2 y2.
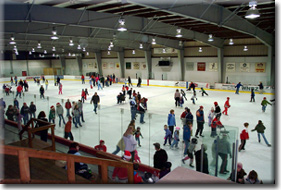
123 126 137 162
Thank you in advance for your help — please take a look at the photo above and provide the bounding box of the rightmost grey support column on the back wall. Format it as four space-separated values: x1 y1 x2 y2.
265 46 275 86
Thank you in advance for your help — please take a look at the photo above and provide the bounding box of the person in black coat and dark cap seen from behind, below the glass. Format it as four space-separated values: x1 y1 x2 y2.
153 143 168 170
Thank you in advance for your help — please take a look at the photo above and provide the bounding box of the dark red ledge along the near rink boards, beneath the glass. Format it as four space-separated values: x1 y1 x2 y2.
5 119 160 177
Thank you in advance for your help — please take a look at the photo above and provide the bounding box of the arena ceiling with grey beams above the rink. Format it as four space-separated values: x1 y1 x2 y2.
3 0 275 52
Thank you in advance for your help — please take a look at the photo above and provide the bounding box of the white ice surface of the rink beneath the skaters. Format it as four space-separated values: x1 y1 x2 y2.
3 80 276 183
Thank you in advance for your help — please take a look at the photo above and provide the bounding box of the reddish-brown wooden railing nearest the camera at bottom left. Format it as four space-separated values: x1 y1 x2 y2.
0 145 134 183
